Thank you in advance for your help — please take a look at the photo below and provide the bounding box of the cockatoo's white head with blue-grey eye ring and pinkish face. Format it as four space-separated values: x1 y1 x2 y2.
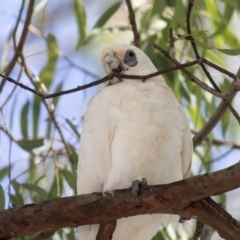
102 43 157 84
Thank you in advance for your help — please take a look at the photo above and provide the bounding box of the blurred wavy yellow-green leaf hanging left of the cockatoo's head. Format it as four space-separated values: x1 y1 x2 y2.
39 34 58 89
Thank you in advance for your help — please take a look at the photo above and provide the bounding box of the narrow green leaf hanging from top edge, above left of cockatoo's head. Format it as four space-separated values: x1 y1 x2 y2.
73 0 87 50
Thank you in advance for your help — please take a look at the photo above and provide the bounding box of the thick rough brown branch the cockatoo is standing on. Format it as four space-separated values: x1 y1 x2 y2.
0 163 240 240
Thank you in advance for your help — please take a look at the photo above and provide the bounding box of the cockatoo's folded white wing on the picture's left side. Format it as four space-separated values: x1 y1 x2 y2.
77 91 114 194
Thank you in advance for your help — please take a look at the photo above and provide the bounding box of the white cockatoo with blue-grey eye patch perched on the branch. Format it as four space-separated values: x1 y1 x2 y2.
77 43 192 240
